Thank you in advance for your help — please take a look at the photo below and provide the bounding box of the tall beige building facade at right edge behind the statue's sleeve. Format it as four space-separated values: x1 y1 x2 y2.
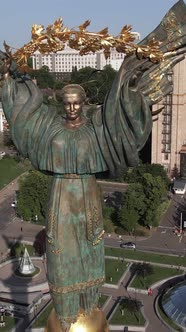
151 59 186 177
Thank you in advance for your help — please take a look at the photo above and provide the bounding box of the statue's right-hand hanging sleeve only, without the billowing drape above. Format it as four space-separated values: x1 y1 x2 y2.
92 59 152 176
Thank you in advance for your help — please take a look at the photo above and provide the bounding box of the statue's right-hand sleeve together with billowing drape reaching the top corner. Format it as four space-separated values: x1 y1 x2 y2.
92 0 186 176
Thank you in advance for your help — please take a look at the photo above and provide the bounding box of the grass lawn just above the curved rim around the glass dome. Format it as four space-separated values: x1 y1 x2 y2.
129 266 180 289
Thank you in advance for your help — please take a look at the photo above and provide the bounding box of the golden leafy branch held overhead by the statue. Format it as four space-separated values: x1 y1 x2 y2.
4 18 163 70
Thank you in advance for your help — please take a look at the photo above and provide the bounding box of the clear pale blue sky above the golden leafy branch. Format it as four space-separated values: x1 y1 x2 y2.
0 0 183 51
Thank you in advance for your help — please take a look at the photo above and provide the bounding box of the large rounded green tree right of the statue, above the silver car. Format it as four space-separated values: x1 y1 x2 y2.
118 169 167 232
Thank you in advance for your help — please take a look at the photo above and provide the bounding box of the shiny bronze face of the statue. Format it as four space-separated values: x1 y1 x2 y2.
63 93 83 121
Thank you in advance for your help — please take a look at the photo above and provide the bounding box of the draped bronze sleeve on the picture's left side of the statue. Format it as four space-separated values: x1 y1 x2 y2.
2 77 60 171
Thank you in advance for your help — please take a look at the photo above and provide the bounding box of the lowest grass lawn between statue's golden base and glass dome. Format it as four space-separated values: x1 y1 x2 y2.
109 306 145 326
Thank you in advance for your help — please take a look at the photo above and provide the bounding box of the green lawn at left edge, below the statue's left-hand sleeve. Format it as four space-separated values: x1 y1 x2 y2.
0 158 25 189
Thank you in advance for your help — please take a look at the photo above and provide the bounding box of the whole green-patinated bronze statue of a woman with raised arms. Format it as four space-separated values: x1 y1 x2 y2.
1 1 186 332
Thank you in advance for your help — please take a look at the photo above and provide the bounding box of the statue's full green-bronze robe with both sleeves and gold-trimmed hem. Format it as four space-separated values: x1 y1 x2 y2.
2 71 151 327
